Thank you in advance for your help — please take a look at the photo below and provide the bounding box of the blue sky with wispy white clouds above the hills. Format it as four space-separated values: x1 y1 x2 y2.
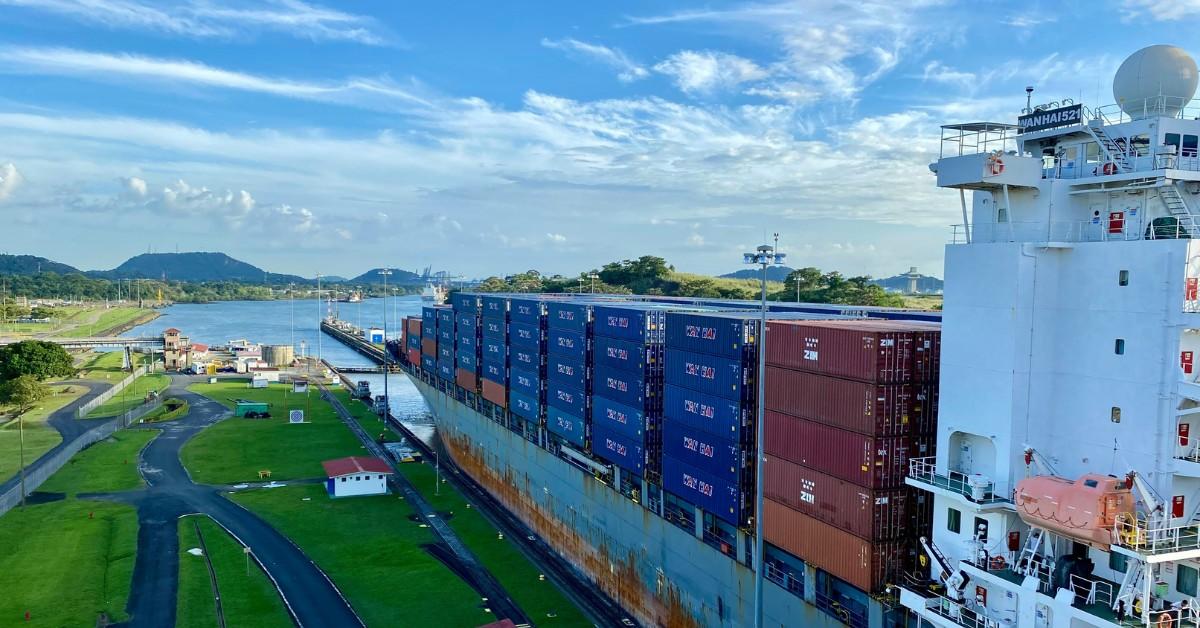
0 0 1200 276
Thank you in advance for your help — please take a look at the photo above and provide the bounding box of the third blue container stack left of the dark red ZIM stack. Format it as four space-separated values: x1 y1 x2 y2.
546 300 592 451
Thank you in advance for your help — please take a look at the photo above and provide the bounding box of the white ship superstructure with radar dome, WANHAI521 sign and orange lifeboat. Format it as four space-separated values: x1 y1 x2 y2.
898 47 1200 627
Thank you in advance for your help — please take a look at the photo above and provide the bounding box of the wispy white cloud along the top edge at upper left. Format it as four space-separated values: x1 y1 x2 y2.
0 0 388 44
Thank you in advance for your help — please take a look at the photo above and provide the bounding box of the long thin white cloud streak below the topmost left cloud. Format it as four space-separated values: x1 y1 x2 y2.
0 48 430 109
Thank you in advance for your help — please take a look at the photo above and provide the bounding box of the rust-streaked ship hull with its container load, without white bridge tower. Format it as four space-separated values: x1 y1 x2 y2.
394 292 941 627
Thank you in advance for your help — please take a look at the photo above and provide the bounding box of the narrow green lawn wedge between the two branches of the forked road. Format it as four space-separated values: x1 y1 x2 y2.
175 515 293 628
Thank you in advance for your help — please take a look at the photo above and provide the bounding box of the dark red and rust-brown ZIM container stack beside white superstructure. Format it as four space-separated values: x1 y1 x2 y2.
762 321 941 592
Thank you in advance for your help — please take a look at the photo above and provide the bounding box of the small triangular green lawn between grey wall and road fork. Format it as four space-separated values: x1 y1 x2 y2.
37 430 158 497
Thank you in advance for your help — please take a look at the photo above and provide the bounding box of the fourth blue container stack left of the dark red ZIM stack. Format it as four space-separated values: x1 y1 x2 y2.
509 298 547 434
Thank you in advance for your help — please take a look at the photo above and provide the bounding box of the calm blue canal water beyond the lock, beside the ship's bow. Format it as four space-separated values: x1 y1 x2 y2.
125 295 433 441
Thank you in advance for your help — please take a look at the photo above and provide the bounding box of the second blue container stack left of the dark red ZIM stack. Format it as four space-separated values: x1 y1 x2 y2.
592 303 667 483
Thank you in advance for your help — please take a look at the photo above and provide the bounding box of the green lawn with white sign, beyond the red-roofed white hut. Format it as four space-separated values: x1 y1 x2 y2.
181 379 365 484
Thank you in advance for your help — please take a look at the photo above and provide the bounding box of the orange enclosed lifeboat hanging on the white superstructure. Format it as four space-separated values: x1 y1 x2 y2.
1015 473 1135 551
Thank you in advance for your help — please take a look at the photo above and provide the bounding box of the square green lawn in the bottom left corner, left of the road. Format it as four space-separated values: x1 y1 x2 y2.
0 500 138 627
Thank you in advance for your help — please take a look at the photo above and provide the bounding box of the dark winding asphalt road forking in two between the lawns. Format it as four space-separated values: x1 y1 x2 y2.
88 378 362 628
